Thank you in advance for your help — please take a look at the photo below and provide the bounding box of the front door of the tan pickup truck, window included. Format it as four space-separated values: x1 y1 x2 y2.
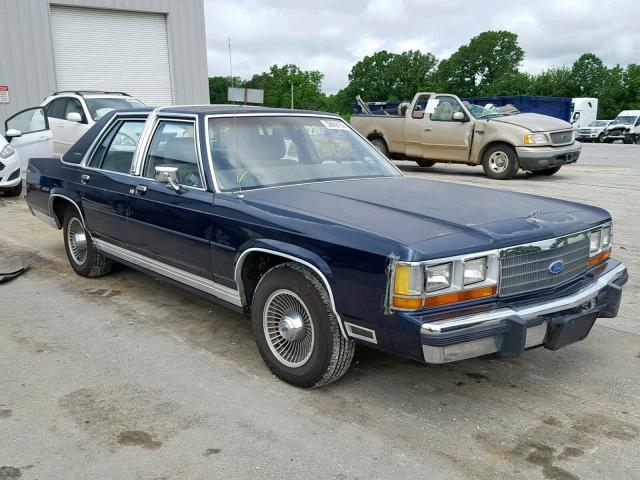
422 95 473 163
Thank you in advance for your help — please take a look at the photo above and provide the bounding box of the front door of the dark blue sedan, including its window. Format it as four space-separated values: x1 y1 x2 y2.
128 119 213 279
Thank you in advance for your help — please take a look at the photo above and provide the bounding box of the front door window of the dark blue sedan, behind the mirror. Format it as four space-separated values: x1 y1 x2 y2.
143 120 204 188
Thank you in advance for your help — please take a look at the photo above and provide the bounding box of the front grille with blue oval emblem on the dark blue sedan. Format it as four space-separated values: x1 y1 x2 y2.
499 233 589 296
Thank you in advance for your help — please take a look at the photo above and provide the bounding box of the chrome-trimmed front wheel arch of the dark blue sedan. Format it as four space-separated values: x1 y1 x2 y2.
234 241 347 338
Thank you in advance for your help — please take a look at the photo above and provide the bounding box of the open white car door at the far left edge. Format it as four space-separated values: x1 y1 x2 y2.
4 107 53 171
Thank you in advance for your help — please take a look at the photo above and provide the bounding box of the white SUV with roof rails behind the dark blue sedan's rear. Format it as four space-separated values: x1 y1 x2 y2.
41 91 145 156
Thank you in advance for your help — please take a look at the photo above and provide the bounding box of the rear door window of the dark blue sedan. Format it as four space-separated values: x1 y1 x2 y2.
89 120 144 173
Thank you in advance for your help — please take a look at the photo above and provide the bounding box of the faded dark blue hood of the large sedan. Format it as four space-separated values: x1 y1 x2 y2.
244 177 610 259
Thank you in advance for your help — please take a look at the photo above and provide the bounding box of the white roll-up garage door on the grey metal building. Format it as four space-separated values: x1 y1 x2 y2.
51 5 173 106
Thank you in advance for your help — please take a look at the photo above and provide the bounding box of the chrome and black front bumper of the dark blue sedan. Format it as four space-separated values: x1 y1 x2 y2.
420 263 629 363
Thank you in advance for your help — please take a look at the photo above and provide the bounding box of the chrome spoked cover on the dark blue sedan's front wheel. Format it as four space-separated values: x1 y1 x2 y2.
262 289 314 368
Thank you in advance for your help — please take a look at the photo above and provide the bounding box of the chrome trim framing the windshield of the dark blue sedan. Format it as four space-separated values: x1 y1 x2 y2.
204 111 406 194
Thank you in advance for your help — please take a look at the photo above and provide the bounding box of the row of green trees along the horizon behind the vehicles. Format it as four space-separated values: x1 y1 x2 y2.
209 31 640 119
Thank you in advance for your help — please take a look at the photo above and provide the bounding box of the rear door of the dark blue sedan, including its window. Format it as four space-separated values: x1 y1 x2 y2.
76 118 144 243
